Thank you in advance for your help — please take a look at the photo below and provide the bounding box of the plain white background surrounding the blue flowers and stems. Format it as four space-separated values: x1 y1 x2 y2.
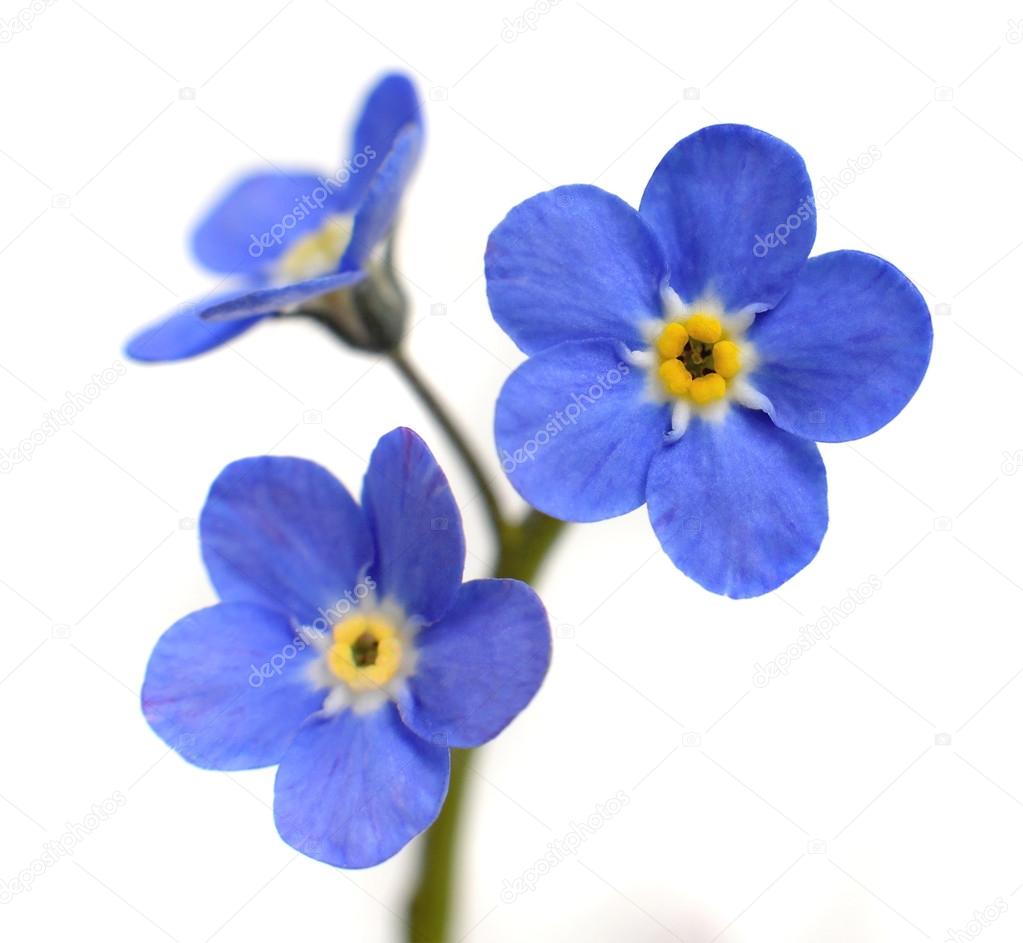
0 0 1023 943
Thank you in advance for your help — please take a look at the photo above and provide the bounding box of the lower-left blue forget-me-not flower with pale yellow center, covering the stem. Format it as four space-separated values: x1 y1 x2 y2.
142 429 550 867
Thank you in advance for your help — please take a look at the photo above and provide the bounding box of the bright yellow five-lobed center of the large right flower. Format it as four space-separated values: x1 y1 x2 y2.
654 314 742 405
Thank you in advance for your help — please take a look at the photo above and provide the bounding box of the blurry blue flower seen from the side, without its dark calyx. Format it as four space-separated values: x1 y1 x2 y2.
126 74 422 361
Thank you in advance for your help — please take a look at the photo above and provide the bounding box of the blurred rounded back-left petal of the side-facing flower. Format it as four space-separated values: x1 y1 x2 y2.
186 171 344 273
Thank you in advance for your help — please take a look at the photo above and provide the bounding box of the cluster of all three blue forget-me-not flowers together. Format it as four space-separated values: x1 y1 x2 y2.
127 75 932 867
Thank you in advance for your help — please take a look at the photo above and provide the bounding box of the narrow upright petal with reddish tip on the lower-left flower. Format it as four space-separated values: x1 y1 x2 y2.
362 429 465 622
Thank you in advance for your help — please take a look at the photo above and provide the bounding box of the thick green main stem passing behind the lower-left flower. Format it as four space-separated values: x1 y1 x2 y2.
407 510 565 943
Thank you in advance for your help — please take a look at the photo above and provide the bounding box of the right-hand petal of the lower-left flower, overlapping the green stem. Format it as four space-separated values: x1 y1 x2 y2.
399 580 550 747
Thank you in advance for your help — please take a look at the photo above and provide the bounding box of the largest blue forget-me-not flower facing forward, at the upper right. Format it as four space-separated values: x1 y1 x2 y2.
486 125 932 597
